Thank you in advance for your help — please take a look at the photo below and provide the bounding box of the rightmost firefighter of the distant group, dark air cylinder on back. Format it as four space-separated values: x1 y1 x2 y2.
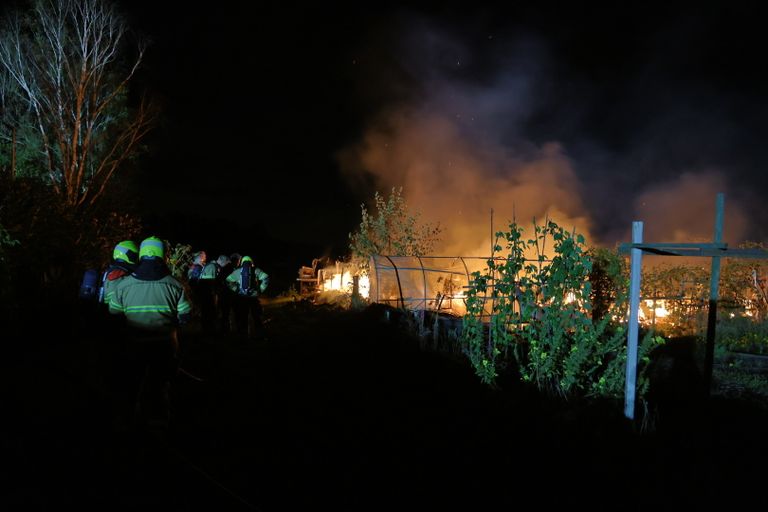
227 256 269 340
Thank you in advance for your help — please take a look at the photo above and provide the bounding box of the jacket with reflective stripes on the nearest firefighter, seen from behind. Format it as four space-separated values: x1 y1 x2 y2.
109 258 192 332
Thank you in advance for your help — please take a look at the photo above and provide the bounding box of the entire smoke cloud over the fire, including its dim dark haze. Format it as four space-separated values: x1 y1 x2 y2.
339 13 759 256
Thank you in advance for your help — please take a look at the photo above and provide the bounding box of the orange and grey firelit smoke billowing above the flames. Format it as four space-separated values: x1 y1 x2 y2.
339 16 747 256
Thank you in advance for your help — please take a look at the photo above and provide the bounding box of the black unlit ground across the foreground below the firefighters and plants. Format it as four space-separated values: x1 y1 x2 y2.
0 302 768 511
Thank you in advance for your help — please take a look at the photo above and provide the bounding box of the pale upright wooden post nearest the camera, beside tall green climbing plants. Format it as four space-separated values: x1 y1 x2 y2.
624 221 643 419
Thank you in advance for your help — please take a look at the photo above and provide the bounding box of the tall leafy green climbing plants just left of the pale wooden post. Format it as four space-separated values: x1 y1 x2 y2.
462 221 663 397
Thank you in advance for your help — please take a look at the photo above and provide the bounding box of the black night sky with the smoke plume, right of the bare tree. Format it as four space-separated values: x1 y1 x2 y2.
117 0 768 268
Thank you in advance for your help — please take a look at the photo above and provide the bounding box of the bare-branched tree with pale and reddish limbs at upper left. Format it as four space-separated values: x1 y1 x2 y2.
0 0 154 208
